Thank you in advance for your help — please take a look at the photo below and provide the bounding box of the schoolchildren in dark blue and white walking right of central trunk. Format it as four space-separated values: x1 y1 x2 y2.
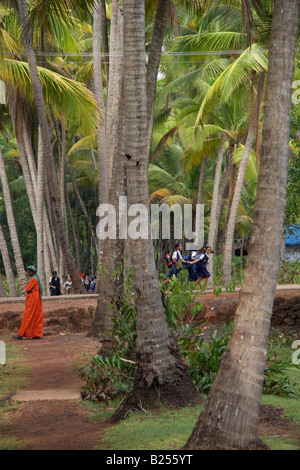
165 243 213 289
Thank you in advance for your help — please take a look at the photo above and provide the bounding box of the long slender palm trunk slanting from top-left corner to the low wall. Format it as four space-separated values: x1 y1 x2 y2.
18 0 84 292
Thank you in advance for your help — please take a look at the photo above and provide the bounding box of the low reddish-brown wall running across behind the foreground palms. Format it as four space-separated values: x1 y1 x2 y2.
0 291 300 335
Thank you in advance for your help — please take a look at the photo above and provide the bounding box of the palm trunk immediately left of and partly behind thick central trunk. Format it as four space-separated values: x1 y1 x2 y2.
91 2 125 340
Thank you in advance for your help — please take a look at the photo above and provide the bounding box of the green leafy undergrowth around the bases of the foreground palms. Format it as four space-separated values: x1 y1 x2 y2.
75 270 300 402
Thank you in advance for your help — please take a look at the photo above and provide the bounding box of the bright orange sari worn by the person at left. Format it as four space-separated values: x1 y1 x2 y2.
18 277 43 338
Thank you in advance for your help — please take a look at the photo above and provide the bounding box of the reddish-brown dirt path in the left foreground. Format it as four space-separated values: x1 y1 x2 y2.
3 334 111 450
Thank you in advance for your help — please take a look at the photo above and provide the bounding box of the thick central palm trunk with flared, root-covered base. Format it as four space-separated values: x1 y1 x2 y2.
115 0 199 419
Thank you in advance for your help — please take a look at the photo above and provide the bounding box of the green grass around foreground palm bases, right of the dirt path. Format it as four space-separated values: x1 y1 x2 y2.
90 341 300 450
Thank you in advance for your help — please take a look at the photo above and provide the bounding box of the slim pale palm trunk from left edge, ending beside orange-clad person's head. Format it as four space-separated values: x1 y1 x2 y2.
0 148 27 295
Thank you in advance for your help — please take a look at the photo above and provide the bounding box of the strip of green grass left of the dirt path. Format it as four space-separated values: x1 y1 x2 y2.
0 344 30 450
